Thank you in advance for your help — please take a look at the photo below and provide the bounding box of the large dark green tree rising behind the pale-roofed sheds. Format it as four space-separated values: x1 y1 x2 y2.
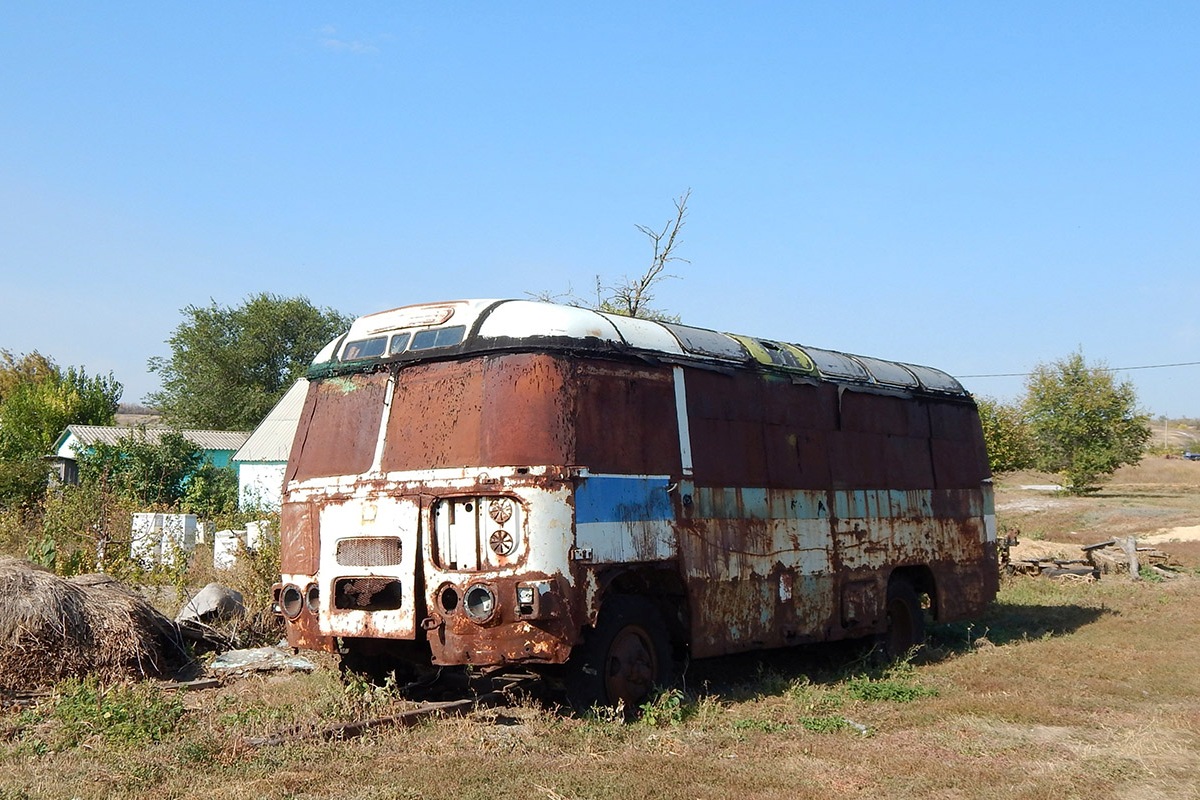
146 294 352 431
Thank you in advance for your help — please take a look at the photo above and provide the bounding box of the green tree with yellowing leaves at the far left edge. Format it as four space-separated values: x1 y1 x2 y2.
0 351 122 507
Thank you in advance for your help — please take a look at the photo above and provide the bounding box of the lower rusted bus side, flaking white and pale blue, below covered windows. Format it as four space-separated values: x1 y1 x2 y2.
680 488 996 657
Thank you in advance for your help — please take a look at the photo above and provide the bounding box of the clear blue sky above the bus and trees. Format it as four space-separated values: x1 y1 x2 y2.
0 0 1200 416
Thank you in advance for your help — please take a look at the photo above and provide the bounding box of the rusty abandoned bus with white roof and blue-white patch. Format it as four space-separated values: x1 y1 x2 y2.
275 300 997 705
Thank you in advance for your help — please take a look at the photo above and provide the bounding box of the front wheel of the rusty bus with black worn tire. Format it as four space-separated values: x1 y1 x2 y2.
566 595 672 712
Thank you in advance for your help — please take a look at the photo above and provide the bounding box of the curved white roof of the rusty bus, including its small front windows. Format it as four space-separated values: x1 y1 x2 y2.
308 300 967 397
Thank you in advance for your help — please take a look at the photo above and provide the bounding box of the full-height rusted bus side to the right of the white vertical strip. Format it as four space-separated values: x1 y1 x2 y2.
679 371 996 657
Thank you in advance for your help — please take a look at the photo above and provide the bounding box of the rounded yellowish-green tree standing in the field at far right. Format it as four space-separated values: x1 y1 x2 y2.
1024 351 1150 494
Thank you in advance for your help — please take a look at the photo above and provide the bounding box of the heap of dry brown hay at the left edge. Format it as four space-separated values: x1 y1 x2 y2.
0 557 187 691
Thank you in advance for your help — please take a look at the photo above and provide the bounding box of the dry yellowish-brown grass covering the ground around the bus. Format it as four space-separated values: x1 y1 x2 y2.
0 464 1200 800
